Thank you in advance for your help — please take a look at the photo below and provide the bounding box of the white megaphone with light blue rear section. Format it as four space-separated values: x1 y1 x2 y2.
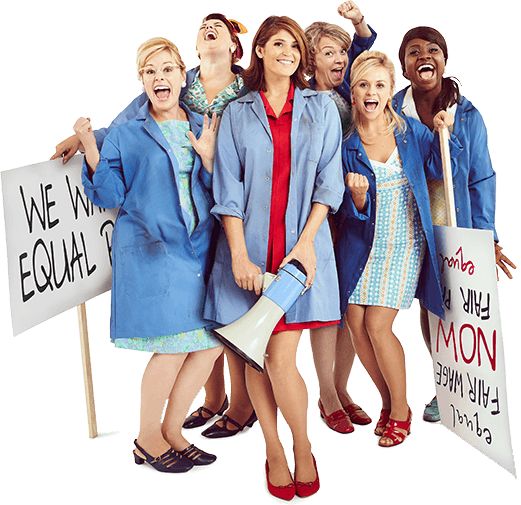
214 260 307 372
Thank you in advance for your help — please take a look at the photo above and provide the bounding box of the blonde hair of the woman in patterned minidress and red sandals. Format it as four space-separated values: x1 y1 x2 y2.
351 51 405 134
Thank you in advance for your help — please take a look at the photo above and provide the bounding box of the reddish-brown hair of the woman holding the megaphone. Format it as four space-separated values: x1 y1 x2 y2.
242 16 309 91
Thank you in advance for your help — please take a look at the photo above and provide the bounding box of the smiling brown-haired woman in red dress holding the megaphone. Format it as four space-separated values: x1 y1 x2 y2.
205 16 344 499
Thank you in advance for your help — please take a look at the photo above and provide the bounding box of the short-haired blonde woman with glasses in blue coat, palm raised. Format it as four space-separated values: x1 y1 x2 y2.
74 38 222 472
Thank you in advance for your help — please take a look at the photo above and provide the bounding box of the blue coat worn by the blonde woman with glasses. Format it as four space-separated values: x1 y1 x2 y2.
82 103 215 339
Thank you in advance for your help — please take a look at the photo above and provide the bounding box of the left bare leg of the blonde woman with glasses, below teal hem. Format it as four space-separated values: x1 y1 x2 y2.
137 354 188 457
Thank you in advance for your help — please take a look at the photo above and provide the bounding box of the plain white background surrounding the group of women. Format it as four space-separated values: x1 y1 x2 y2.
0 0 521 504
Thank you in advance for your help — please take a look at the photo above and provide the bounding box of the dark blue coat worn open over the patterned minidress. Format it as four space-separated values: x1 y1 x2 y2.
335 118 462 318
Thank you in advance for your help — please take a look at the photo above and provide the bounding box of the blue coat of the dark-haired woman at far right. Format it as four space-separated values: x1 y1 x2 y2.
393 88 498 241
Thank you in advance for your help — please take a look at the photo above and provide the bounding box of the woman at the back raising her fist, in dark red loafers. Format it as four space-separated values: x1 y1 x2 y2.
305 1 376 433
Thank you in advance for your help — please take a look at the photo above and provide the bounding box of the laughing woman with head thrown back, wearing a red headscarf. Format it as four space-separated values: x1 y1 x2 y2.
51 13 256 438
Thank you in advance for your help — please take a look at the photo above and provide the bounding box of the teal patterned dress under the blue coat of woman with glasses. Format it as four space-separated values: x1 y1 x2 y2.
114 119 221 354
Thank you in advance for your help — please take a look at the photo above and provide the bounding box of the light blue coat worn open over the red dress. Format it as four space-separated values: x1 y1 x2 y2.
204 89 344 324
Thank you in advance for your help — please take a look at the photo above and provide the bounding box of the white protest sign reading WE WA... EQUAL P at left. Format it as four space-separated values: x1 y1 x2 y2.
2 156 116 335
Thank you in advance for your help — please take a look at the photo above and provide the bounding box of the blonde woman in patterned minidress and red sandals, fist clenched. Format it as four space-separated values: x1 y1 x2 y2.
336 51 461 447
